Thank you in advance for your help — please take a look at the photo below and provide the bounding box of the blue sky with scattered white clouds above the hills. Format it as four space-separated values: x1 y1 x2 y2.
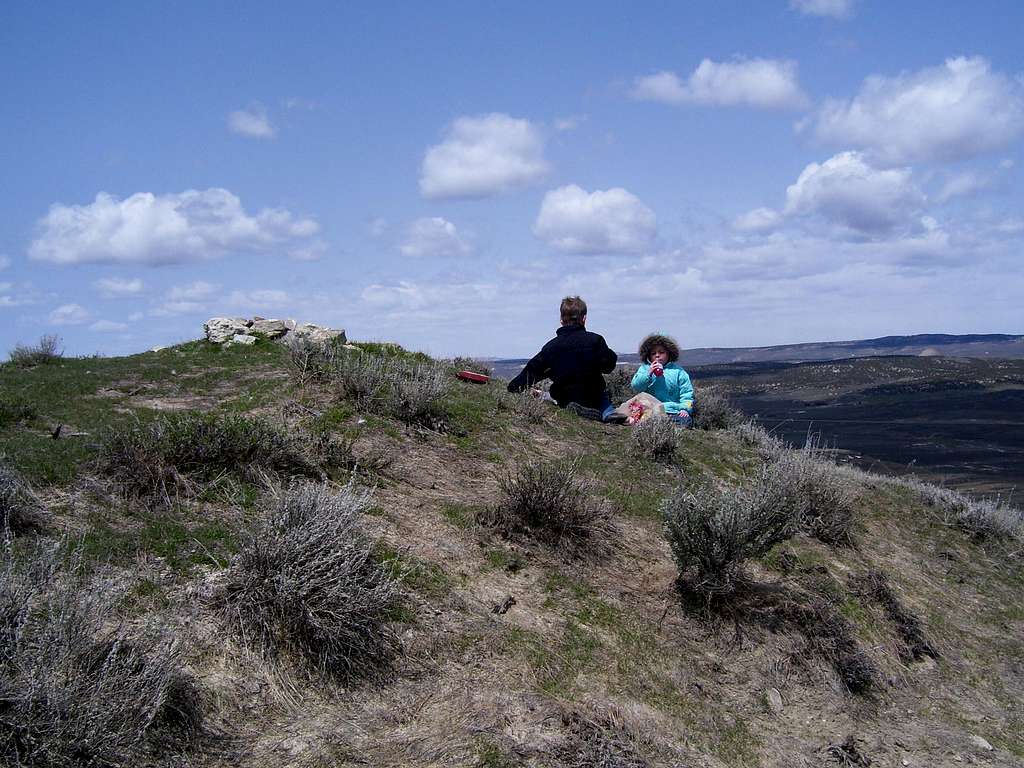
0 0 1024 356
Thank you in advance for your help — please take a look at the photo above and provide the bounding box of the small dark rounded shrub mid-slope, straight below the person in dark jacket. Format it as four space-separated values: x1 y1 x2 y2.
477 461 610 553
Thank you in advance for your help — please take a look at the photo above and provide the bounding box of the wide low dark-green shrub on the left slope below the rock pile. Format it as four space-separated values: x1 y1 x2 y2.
98 413 323 503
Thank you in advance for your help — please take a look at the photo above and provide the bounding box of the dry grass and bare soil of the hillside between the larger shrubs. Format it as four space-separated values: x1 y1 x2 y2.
0 342 1024 768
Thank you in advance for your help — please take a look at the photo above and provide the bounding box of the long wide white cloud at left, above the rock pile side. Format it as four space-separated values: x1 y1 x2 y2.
29 188 319 264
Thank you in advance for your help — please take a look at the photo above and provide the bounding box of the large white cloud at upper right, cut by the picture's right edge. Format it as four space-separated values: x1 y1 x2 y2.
814 56 1024 165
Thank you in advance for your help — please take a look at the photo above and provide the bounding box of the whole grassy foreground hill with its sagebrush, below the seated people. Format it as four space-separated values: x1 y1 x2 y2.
0 341 1024 768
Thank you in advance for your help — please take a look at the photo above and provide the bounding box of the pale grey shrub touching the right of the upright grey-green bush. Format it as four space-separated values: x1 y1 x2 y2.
766 442 856 545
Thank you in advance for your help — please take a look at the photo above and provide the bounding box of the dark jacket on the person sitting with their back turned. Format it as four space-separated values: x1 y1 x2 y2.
509 326 616 408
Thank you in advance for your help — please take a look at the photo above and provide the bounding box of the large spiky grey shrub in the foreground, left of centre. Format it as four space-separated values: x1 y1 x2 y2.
219 483 397 679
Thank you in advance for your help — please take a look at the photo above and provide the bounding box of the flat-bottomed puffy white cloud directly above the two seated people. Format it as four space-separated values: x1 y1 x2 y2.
534 184 657 254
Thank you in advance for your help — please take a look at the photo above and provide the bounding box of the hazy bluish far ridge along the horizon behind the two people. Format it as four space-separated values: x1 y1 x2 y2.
495 334 1024 377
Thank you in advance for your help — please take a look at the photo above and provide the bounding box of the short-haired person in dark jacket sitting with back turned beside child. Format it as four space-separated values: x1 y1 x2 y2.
509 296 626 424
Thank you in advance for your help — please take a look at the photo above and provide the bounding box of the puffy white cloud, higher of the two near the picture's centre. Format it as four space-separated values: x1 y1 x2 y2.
420 113 548 199
